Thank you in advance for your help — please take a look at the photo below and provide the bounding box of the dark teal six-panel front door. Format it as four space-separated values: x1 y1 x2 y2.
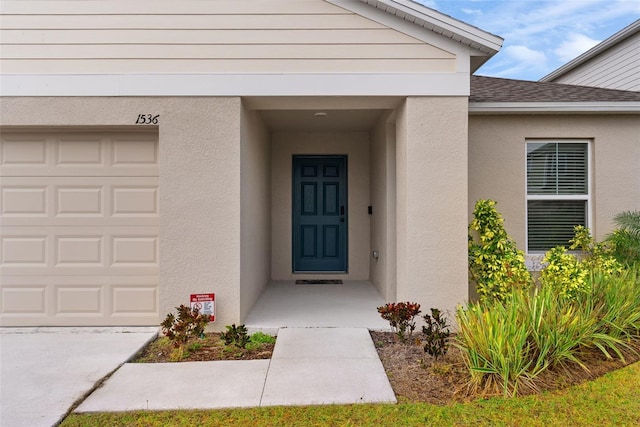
293 156 347 272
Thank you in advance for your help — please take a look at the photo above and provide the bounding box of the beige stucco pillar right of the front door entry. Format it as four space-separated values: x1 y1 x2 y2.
396 97 468 316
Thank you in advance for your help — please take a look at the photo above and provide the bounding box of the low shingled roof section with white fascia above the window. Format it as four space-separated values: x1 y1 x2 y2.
469 76 640 113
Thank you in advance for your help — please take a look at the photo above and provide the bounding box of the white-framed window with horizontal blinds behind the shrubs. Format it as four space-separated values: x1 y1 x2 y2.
527 141 589 252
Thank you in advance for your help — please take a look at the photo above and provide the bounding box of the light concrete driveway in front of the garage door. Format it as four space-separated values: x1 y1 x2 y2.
0 327 158 427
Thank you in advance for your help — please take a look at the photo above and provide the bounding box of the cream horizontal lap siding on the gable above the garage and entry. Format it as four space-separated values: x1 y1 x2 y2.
0 0 456 74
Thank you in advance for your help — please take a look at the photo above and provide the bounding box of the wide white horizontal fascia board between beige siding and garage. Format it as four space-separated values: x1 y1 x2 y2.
0 72 470 96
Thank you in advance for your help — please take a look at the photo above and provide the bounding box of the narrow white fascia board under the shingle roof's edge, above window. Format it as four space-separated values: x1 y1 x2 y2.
469 101 640 114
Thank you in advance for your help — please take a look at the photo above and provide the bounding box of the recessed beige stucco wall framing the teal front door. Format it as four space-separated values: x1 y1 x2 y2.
271 132 370 280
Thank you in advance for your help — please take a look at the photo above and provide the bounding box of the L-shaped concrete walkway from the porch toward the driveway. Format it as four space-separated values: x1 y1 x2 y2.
75 328 396 412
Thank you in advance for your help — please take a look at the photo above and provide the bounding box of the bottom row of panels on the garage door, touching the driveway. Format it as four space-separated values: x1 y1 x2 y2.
1 276 158 326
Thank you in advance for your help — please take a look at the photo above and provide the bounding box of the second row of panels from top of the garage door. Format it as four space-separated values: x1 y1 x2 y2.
0 177 160 226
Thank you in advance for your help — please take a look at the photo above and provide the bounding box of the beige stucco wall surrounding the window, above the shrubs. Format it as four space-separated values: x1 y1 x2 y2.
469 115 640 250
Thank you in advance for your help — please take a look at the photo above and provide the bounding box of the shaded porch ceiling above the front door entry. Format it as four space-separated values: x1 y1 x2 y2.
260 109 384 132
